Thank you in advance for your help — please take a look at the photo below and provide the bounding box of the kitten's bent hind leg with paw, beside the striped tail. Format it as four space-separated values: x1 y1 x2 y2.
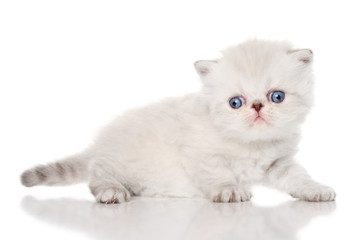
89 161 131 204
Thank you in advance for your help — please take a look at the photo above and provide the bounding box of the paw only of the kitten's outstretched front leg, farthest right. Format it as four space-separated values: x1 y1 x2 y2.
290 185 336 202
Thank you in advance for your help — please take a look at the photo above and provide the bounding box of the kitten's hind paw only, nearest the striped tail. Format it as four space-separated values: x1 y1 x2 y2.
95 188 130 204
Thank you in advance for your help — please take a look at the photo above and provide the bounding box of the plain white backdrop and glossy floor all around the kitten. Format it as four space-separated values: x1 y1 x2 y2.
0 0 360 239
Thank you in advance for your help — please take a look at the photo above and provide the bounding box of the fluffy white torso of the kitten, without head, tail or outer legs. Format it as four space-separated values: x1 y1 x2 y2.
92 94 296 197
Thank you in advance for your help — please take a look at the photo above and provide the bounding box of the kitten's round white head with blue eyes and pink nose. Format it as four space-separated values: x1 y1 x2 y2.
195 40 313 141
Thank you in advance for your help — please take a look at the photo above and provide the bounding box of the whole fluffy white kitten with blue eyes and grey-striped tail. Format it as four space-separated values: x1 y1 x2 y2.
21 40 335 203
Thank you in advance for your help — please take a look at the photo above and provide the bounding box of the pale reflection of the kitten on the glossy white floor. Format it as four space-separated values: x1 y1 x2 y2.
22 197 335 240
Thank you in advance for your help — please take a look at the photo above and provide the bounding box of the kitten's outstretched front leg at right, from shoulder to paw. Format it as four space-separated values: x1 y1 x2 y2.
265 159 336 202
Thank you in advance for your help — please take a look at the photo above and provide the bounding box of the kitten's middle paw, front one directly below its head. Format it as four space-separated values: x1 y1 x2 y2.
211 188 252 202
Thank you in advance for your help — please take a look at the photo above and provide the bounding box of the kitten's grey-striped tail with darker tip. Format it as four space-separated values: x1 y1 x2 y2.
21 153 89 187
